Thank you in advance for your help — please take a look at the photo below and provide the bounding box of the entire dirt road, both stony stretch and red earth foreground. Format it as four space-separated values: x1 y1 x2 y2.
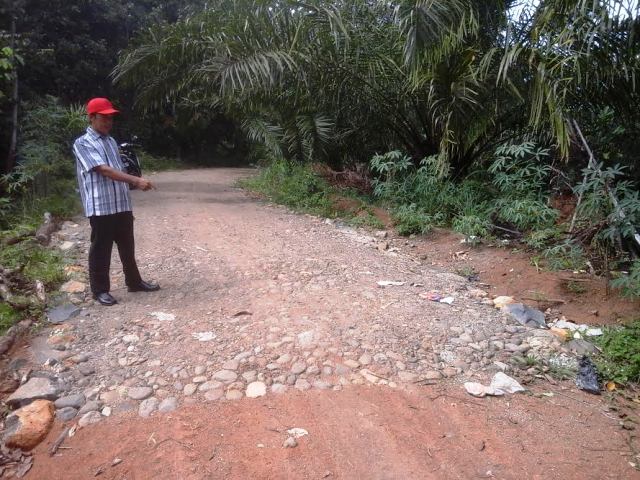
17 169 640 479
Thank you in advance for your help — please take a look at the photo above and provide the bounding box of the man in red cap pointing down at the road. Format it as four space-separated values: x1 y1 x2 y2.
73 98 160 306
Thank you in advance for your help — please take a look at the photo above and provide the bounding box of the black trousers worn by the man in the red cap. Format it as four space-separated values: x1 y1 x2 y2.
89 212 142 294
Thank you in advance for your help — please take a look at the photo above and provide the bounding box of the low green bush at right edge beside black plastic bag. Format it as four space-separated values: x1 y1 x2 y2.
595 320 640 384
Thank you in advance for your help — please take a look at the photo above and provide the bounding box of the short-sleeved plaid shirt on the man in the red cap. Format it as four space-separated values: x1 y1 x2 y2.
73 127 132 217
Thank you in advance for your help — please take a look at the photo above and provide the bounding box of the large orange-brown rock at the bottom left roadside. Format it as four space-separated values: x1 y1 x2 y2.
3 400 55 450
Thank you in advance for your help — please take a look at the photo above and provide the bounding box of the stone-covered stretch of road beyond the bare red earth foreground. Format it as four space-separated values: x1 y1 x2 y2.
3 169 636 478
